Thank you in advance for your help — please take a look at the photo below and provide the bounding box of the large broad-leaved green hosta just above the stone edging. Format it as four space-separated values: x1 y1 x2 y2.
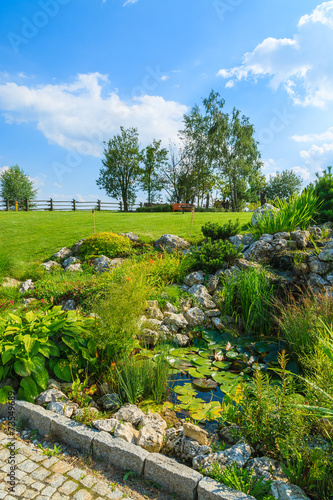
0 307 97 402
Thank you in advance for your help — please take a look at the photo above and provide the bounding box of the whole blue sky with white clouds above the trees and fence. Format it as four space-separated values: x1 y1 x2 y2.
0 0 333 201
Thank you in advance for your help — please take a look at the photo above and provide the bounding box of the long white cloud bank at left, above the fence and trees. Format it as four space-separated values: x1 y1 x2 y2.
0 73 187 156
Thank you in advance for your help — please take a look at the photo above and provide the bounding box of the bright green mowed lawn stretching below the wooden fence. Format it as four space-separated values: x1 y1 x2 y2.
0 212 251 263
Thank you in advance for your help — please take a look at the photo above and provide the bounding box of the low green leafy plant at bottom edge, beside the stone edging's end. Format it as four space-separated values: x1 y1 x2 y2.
205 462 274 500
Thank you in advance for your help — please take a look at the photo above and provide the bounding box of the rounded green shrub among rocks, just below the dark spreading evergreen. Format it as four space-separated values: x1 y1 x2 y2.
190 239 242 271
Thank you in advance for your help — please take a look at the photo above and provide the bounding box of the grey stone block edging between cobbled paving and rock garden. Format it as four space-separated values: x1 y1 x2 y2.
0 401 255 500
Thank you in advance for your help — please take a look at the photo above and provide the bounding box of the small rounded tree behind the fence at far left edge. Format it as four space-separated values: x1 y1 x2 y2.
0 165 38 208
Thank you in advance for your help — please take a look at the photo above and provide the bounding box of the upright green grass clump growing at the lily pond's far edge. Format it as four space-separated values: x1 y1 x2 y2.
221 267 273 335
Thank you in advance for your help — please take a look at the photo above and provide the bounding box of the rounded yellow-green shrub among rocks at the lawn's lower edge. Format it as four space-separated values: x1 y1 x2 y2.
80 232 132 260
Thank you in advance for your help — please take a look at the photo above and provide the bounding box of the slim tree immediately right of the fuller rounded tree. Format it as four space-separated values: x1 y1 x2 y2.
140 139 168 206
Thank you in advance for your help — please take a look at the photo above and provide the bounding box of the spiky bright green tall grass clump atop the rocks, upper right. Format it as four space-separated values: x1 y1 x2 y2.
249 190 322 239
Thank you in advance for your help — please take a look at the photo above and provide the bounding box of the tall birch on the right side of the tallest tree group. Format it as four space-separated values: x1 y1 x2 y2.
203 91 262 212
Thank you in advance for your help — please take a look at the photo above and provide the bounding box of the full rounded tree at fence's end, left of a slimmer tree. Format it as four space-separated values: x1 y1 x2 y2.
96 127 141 212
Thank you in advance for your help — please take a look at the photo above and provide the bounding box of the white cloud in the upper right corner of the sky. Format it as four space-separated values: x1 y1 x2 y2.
218 0 333 107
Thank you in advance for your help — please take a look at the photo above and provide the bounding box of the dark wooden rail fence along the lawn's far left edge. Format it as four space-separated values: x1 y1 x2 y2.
0 198 142 212
